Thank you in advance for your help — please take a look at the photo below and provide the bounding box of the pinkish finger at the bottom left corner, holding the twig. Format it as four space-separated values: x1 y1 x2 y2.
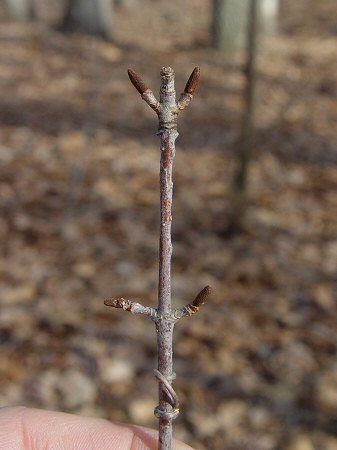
0 407 191 450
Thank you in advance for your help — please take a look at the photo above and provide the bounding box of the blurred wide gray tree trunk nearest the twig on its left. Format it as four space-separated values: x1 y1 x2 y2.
61 0 114 40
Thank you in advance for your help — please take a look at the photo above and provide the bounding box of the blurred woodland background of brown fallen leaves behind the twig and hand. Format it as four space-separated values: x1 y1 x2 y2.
0 0 337 450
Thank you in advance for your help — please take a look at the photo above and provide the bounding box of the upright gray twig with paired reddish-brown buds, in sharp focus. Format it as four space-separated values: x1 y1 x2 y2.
105 67 211 450
